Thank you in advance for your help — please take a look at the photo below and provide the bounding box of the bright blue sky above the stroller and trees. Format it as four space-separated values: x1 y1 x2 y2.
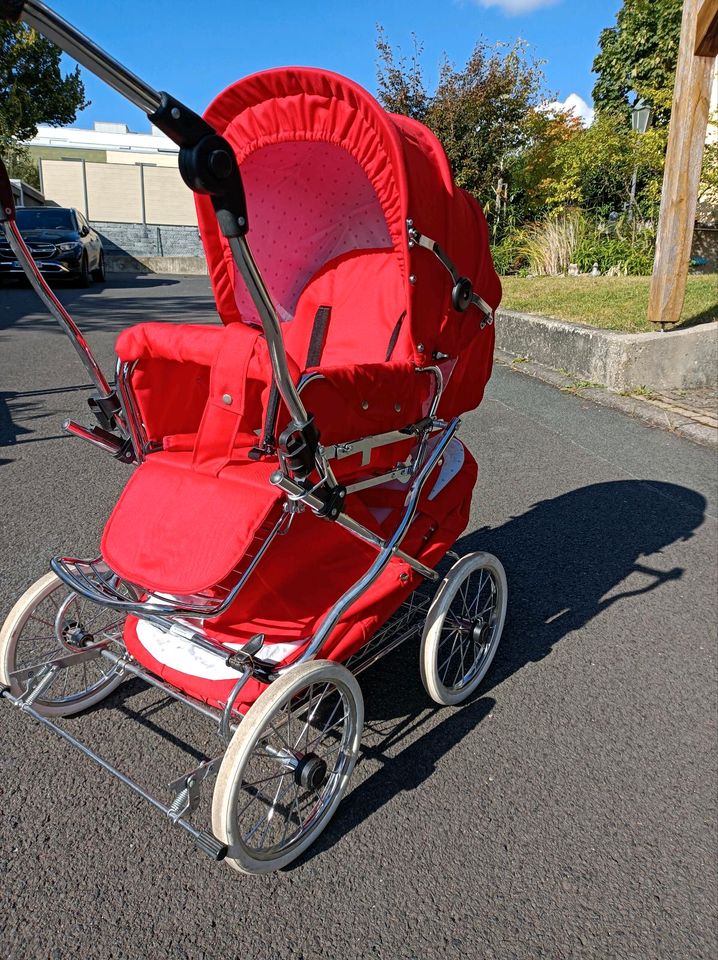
50 0 621 131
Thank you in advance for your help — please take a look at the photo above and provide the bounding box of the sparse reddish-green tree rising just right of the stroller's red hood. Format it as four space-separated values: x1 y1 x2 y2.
377 28 545 205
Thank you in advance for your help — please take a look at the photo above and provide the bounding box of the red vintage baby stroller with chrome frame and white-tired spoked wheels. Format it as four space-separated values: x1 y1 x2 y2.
0 0 506 873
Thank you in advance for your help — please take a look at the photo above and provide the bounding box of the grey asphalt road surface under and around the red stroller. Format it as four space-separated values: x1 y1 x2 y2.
0 277 718 960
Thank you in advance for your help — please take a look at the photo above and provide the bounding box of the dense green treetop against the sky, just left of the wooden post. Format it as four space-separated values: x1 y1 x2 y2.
593 0 683 127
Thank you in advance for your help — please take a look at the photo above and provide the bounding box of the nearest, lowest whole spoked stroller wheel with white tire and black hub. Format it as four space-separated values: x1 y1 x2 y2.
212 660 364 874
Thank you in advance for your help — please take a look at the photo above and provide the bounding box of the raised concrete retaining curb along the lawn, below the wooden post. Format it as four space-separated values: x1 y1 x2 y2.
496 310 718 390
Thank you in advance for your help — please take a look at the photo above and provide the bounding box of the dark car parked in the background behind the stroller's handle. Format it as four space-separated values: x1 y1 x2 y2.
0 207 105 287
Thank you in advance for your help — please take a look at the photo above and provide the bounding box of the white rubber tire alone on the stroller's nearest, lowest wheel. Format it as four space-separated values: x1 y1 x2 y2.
212 660 364 874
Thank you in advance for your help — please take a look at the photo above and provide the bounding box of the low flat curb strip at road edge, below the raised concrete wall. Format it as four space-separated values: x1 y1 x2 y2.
494 349 718 447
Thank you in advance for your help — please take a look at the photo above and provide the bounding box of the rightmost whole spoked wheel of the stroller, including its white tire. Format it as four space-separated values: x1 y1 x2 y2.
421 553 507 705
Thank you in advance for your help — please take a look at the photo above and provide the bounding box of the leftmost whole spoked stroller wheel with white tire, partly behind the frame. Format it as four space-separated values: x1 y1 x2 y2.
0 573 124 717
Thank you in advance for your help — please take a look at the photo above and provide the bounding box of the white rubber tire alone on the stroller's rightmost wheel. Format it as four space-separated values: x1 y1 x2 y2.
420 553 508 706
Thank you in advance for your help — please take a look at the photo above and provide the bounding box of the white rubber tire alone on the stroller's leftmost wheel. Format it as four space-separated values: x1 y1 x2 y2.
0 571 123 717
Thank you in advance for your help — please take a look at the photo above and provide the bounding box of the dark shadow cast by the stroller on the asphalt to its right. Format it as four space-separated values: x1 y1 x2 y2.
298 480 706 870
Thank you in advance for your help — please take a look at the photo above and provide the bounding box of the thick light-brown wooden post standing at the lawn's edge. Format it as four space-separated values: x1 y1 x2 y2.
648 0 718 326
